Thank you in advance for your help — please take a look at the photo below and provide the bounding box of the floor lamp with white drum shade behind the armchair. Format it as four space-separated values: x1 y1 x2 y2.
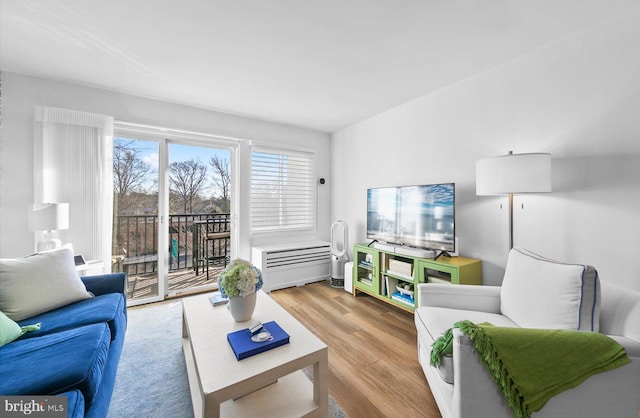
476 151 551 249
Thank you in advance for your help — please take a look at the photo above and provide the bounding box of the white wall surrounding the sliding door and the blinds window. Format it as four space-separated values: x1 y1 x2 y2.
0 72 331 258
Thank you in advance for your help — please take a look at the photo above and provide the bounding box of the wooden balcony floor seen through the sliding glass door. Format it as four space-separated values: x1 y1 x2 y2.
127 265 224 299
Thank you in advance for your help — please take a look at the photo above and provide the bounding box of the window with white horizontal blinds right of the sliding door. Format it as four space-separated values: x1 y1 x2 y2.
251 147 316 232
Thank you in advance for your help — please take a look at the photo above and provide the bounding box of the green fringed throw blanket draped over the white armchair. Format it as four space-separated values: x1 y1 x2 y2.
431 321 631 418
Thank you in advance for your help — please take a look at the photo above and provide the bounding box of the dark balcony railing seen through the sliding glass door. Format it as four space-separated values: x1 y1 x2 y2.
112 213 231 275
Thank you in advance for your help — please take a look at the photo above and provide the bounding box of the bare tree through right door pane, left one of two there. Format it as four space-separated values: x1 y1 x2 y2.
169 159 207 213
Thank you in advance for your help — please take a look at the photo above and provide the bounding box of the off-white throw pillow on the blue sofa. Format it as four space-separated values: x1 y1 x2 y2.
0 248 91 321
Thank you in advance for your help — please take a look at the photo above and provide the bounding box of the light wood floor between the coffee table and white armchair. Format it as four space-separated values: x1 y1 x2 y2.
270 282 440 418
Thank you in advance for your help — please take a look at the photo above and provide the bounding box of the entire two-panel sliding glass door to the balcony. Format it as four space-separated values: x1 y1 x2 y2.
112 130 235 304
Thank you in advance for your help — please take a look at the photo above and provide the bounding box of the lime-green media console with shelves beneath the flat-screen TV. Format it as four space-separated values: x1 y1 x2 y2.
352 244 482 312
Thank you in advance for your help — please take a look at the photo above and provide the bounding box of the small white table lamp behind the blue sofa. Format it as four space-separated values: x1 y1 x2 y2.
28 203 69 252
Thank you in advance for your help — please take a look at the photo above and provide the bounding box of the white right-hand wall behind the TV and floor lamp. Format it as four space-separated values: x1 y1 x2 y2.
332 12 640 290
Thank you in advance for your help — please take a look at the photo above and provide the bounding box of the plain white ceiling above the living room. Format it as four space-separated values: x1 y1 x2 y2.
0 0 638 132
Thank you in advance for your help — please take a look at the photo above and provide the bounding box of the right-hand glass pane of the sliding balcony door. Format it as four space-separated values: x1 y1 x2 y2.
167 141 232 295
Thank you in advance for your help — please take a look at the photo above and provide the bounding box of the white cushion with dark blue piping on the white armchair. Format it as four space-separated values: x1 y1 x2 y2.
500 248 600 332
